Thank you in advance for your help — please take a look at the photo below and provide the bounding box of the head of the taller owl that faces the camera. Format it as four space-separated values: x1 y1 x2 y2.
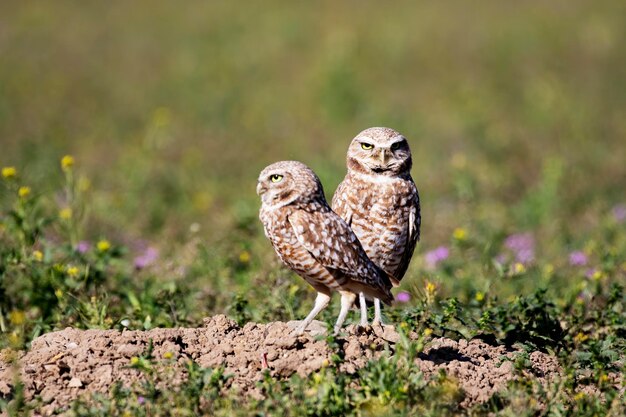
347 127 413 177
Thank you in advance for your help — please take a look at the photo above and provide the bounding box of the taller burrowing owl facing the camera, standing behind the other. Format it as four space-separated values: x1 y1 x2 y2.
332 127 421 325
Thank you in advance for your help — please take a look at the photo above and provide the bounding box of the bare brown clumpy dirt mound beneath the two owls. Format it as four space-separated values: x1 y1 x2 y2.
0 315 559 414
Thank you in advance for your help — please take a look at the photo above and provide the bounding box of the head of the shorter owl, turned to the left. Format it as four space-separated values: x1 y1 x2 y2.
256 161 325 208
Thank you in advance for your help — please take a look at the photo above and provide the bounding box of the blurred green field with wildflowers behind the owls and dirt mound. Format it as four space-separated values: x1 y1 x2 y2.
0 0 626 412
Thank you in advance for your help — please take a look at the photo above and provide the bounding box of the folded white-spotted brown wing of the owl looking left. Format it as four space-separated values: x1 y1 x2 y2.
289 210 393 303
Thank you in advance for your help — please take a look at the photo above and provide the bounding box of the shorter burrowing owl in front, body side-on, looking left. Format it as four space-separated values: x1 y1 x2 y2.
257 161 393 333
